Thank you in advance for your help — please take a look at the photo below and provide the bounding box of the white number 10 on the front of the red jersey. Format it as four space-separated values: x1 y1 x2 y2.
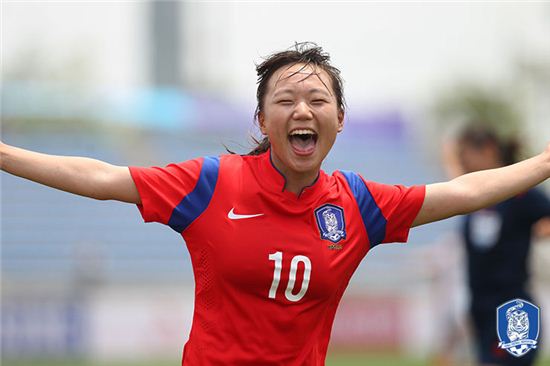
269 252 311 302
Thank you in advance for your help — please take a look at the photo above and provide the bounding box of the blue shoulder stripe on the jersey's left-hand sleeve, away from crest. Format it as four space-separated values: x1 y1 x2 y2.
168 156 220 233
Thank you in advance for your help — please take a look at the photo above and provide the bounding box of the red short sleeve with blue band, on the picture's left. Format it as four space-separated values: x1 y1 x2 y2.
129 157 219 232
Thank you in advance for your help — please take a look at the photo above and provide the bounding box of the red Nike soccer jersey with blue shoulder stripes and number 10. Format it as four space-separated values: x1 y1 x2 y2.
130 152 425 366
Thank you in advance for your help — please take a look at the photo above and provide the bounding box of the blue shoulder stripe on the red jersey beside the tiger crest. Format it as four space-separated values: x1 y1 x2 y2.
340 170 387 248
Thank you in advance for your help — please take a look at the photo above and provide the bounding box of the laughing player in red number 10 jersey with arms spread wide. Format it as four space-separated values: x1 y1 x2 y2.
0 44 550 365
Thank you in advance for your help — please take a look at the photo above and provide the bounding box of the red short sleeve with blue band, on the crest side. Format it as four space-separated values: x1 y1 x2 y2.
341 171 426 248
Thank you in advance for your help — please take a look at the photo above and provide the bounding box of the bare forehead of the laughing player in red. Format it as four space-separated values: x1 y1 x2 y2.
268 63 332 94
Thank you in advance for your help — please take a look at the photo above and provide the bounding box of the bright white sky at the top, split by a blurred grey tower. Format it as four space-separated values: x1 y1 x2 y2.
2 1 550 105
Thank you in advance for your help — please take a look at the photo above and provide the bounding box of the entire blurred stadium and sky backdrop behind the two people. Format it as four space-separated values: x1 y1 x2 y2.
1 1 550 365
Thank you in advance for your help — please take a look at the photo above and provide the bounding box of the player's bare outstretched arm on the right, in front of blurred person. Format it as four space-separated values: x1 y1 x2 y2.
413 144 550 226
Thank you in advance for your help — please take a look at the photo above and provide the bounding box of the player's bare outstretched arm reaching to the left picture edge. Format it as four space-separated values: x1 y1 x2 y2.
0 142 141 203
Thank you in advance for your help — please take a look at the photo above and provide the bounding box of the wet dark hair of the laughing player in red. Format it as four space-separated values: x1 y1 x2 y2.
248 42 346 155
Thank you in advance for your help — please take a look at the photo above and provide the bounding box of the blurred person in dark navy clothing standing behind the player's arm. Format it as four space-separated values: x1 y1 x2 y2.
444 123 550 366
